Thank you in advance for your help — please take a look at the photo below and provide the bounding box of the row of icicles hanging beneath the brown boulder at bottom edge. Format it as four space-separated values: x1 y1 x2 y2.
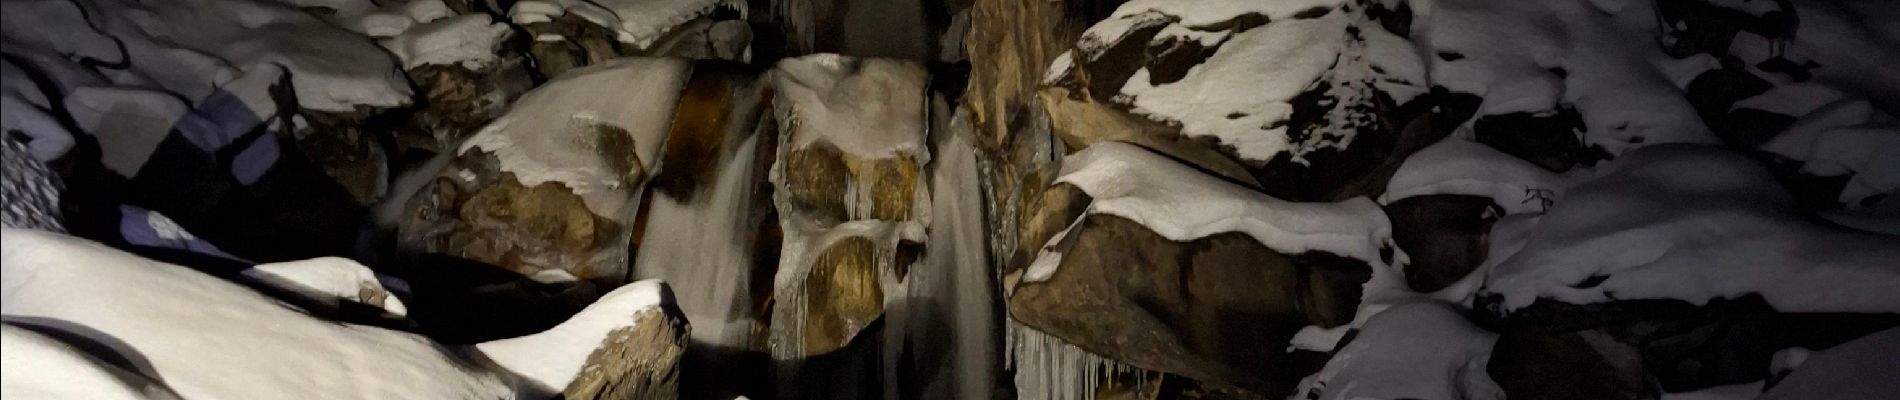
1005 320 1159 400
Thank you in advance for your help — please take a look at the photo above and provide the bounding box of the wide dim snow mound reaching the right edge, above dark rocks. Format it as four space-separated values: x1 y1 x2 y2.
1486 144 1900 313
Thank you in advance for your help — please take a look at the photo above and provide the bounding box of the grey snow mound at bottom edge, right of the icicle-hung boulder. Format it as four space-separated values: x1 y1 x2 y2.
1300 301 1505 400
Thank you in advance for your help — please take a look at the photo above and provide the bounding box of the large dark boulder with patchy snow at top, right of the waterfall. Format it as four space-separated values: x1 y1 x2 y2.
1039 2 1436 201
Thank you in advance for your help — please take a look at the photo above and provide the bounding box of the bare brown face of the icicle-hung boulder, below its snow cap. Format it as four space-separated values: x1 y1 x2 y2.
1005 184 1372 394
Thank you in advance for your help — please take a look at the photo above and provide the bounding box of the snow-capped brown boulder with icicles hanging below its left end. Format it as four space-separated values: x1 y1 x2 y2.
1003 142 1404 396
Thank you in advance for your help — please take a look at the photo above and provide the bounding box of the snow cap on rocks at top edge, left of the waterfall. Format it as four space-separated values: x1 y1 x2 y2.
507 0 747 49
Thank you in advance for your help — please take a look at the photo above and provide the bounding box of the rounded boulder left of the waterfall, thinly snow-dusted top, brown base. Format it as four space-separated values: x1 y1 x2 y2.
399 59 688 282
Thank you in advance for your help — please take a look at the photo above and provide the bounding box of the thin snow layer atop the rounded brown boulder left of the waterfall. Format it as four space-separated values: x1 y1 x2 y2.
458 57 690 216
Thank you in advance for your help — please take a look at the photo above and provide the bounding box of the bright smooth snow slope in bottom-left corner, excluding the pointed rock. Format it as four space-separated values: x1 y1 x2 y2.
0 229 515 398
